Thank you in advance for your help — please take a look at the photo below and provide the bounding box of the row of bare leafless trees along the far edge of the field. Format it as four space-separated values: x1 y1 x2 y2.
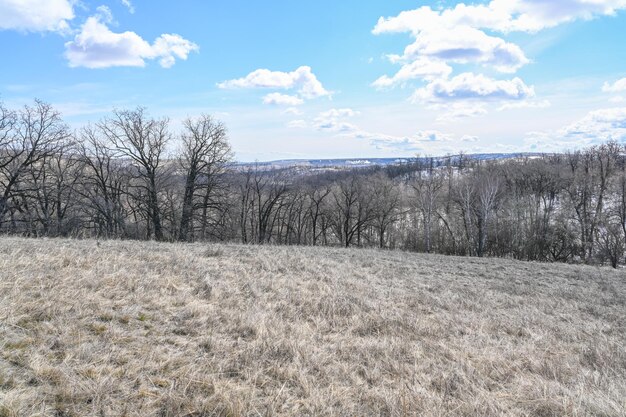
0 101 626 267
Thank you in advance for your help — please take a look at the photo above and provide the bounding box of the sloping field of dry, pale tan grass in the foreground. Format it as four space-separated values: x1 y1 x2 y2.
0 238 626 417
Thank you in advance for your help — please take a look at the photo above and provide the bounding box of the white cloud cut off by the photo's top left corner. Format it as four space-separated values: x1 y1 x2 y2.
0 0 74 32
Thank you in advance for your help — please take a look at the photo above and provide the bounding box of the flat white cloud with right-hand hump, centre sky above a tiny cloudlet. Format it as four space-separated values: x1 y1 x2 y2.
218 66 330 99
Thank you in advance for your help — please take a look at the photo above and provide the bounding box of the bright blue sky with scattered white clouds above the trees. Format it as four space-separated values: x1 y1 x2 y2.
0 0 626 161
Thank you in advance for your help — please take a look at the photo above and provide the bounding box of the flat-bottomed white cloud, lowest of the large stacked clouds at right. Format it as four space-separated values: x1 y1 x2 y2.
413 72 535 102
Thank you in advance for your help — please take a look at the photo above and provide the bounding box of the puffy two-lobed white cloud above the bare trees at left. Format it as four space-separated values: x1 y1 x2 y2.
65 13 198 68
